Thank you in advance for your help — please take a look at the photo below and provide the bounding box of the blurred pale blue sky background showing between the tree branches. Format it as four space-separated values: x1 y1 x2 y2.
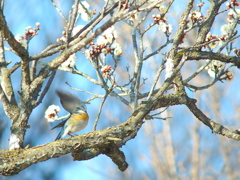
0 0 240 180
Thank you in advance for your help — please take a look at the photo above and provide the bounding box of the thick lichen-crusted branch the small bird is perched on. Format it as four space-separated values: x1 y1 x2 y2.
0 95 186 176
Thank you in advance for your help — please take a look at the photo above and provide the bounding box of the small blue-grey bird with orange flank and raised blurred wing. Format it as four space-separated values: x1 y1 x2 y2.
52 90 89 140
